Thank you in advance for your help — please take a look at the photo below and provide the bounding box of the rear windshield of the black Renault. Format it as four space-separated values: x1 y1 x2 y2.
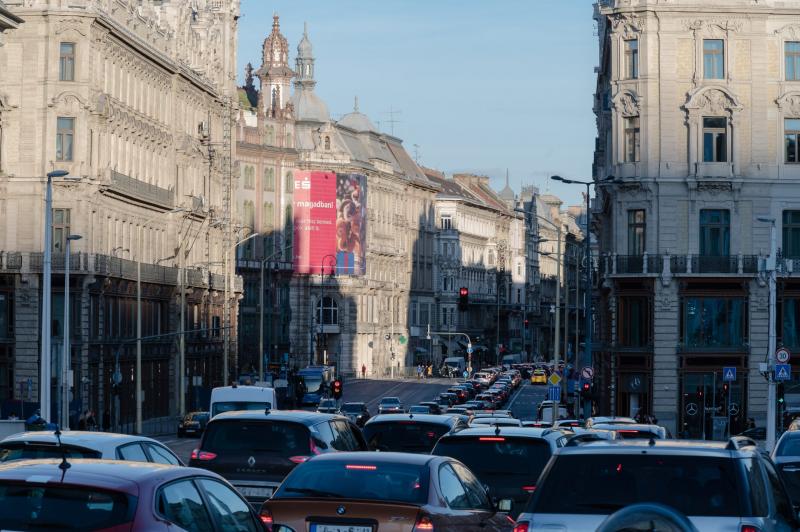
202 420 311 456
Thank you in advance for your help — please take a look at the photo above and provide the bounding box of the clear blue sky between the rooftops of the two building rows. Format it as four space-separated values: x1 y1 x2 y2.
239 0 597 203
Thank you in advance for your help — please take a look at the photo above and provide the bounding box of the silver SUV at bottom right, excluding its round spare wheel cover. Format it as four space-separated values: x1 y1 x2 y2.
516 437 800 532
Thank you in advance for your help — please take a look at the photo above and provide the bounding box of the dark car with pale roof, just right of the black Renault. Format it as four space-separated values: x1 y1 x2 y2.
363 414 467 453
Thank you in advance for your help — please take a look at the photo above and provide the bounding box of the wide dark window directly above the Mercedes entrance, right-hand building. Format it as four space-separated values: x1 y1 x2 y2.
681 297 747 348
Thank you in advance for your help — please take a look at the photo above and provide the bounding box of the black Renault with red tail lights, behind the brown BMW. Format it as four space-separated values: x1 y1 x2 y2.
189 410 368 504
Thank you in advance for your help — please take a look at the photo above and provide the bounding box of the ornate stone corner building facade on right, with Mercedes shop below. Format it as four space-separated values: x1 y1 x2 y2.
593 0 800 438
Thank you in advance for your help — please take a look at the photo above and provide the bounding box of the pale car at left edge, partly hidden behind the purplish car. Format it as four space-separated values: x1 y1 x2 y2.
0 430 183 465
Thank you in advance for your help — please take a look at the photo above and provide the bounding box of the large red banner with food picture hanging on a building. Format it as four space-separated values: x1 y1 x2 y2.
293 171 367 275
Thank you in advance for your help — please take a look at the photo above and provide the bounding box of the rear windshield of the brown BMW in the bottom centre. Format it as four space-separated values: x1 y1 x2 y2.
273 460 428 504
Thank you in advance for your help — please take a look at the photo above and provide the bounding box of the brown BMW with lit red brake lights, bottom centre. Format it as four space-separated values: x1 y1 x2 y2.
261 453 514 532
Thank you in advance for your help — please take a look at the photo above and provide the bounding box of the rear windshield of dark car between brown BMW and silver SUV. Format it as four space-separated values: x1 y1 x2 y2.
433 436 551 480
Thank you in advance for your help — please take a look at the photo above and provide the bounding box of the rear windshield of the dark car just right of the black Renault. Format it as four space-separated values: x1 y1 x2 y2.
364 420 450 453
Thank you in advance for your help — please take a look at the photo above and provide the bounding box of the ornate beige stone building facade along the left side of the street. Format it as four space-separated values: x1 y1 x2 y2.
0 0 240 422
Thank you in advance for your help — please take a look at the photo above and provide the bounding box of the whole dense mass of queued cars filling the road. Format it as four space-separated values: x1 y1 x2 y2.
0 363 800 532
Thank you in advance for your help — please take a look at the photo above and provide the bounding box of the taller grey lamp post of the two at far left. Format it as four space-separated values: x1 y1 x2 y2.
39 170 69 420
